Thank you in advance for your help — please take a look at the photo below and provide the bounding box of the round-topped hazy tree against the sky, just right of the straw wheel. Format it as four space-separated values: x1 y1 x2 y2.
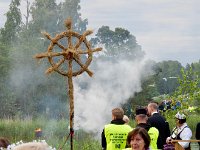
91 26 144 60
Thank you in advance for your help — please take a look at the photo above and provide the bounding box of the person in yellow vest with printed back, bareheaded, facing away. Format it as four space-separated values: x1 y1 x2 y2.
101 108 132 150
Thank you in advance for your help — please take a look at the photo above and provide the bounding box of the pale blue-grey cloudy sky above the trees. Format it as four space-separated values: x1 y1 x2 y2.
0 0 200 65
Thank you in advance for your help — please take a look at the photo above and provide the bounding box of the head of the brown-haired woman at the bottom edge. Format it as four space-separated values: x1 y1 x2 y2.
127 127 150 150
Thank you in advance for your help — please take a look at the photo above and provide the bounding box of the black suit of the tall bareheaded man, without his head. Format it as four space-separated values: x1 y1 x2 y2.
147 113 170 149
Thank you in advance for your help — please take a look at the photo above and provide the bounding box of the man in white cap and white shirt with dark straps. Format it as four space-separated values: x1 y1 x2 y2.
166 112 192 150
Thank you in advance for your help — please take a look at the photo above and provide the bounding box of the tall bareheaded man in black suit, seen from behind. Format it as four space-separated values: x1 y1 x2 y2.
147 102 170 149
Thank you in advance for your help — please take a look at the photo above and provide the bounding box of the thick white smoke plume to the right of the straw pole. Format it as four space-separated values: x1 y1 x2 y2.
74 56 152 134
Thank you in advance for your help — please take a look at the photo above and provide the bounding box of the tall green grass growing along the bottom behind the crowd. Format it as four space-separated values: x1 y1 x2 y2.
0 115 200 150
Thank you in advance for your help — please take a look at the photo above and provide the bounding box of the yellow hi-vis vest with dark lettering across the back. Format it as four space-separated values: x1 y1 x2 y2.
104 124 132 150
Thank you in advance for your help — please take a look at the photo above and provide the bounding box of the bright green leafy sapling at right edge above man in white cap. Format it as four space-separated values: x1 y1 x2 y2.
165 67 200 116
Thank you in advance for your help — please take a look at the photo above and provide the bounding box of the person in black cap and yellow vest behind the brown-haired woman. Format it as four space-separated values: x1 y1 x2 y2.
135 108 159 150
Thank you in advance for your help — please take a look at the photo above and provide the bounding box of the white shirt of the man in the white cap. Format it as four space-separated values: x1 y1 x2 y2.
167 123 192 148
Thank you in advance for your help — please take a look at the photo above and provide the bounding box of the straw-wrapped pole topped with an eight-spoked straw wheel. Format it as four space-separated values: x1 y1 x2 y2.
35 18 102 150
